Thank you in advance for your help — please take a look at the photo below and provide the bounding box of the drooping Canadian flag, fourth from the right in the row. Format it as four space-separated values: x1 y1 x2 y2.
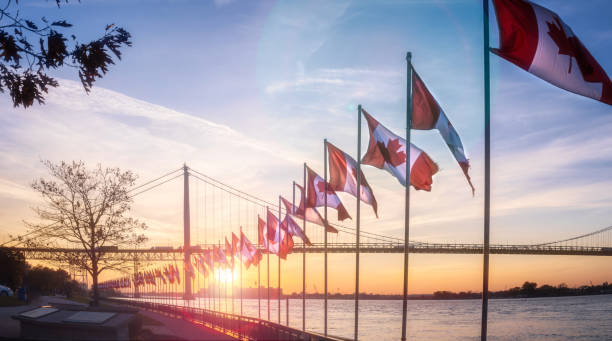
327 142 378 217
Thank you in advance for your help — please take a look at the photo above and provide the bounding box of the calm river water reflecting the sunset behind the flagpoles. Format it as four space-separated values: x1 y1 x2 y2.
124 295 612 341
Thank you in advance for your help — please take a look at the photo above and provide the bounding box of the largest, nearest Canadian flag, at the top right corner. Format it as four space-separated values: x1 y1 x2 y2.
491 0 612 105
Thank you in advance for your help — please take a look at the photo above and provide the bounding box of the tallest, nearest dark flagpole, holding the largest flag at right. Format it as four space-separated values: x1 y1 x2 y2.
480 0 491 341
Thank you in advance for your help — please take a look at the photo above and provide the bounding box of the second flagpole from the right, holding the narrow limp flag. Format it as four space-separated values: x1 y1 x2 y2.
402 52 412 341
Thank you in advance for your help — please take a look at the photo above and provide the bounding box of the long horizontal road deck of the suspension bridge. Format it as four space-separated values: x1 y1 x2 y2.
7 242 612 261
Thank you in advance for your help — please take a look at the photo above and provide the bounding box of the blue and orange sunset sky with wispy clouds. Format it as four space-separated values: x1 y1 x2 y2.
0 0 612 293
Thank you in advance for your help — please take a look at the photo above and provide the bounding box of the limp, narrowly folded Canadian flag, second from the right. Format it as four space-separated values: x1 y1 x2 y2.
411 69 474 194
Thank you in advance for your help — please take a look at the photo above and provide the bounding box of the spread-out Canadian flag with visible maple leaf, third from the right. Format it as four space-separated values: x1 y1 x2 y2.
361 110 438 191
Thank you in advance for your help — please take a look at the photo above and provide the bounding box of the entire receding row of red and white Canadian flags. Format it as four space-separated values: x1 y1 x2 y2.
100 0 612 294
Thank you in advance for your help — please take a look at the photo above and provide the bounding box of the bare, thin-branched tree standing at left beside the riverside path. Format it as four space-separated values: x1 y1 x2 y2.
25 161 146 305
